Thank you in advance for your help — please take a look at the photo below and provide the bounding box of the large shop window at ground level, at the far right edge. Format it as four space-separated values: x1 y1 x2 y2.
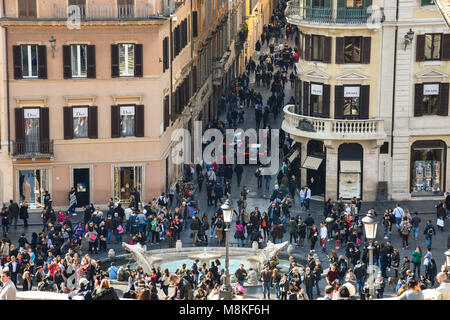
410 140 447 196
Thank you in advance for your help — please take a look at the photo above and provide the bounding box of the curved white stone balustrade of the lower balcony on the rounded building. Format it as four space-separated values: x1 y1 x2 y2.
282 105 386 140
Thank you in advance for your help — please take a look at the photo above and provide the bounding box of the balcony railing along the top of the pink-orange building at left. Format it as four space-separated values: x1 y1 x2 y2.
54 4 170 21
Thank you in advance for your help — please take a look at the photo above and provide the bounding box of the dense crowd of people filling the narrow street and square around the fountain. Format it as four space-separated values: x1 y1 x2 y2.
0 1 450 300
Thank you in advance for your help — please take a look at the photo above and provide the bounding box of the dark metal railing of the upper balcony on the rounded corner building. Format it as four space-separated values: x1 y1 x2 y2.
285 2 384 25
